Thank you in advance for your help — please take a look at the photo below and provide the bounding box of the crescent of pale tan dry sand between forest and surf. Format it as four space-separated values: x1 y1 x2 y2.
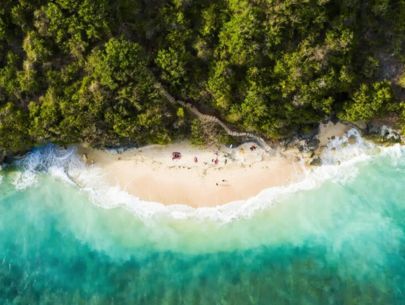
78 122 356 208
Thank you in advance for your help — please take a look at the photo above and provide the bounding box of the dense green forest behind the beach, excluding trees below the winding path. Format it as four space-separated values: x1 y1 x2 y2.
0 0 405 152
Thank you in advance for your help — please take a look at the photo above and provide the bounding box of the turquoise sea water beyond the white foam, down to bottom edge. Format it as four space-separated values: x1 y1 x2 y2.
0 147 405 305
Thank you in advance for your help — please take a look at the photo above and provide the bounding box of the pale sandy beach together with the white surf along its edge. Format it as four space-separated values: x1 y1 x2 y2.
2 122 405 211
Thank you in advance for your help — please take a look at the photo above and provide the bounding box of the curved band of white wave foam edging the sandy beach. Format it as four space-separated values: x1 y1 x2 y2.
8 129 405 222
